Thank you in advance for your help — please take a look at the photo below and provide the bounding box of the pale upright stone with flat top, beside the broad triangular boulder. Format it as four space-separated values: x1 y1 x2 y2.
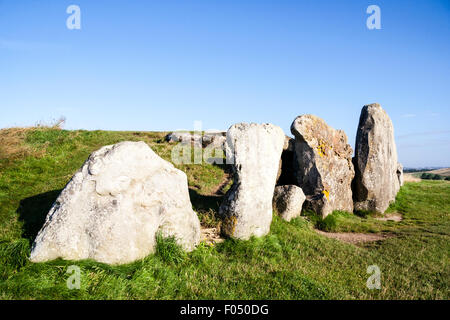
219 123 285 240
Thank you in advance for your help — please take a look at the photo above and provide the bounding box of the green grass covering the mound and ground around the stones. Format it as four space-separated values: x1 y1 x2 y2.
0 128 450 299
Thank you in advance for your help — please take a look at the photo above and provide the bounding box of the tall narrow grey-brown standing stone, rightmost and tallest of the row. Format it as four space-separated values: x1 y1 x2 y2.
353 104 400 213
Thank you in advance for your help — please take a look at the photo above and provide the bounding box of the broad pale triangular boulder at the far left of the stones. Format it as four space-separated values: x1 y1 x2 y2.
30 142 200 264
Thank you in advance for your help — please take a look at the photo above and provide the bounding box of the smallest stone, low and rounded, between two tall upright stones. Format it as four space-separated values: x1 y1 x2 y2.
273 185 305 221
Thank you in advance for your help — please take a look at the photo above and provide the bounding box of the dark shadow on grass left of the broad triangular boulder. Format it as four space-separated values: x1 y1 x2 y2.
17 190 61 242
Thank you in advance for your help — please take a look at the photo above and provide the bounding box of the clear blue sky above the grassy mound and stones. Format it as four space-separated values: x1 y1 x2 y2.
0 0 450 166
